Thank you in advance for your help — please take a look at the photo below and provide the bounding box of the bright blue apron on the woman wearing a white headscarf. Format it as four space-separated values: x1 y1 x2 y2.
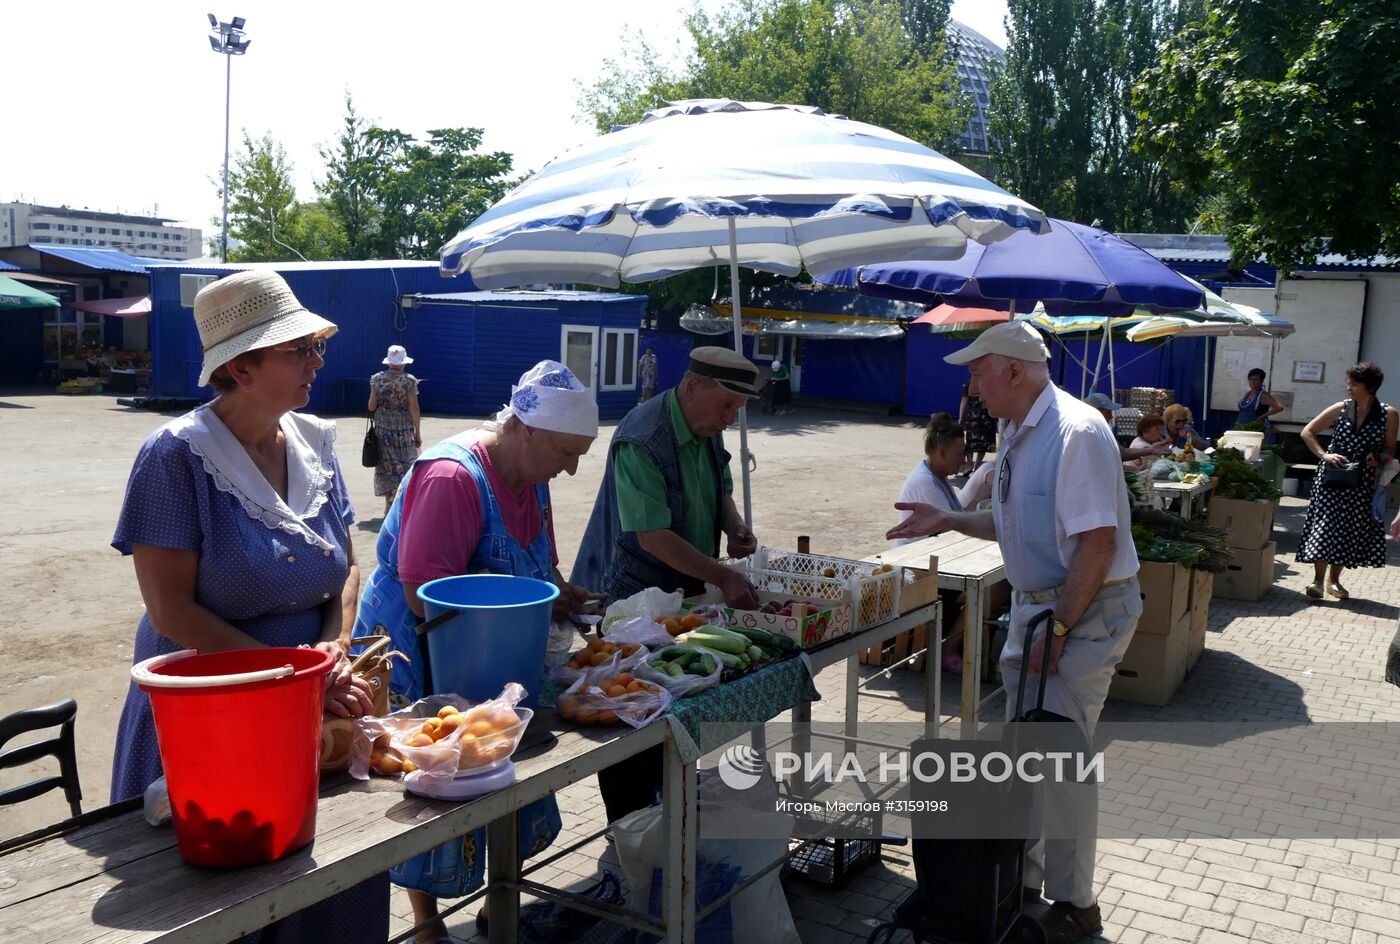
354 440 563 898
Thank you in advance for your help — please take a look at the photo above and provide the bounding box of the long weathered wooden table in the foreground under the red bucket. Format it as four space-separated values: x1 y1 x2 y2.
0 601 939 944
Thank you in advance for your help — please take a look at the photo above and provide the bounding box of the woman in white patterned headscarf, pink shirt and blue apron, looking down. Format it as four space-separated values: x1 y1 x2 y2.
356 360 598 944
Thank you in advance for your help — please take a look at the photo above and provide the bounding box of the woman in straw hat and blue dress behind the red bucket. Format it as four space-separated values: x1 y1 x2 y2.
112 272 389 944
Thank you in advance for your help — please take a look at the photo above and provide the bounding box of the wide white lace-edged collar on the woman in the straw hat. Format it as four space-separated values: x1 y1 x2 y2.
165 403 336 550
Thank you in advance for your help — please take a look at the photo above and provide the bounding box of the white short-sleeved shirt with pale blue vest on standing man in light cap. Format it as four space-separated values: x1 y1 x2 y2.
993 384 1138 591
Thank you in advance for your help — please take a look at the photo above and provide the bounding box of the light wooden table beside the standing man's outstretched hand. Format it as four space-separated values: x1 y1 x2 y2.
867 531 1007 738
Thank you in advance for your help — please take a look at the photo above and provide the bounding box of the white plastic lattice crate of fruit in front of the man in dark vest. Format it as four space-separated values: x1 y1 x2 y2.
743 548 904 630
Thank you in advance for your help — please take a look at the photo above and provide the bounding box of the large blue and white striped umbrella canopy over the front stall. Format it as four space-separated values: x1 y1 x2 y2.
441 99 1047 289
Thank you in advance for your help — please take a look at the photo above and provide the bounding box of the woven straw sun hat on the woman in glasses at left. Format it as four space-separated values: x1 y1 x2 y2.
195 270 339 387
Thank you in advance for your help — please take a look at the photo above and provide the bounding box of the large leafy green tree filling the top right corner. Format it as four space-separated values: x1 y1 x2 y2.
1135 0 1400 269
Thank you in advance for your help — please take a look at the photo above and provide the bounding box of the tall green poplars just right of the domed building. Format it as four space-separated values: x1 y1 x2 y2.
990 0 1200 230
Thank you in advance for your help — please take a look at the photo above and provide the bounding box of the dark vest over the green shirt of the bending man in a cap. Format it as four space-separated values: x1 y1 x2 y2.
568 392 729 604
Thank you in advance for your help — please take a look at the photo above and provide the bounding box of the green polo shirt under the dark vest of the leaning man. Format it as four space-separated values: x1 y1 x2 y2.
613 389 734 557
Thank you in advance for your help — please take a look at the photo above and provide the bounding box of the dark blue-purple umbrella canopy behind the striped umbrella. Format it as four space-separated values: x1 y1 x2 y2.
816 218 1204 318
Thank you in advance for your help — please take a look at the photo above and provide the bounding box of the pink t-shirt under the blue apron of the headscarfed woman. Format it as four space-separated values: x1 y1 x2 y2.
399 441 559 584
